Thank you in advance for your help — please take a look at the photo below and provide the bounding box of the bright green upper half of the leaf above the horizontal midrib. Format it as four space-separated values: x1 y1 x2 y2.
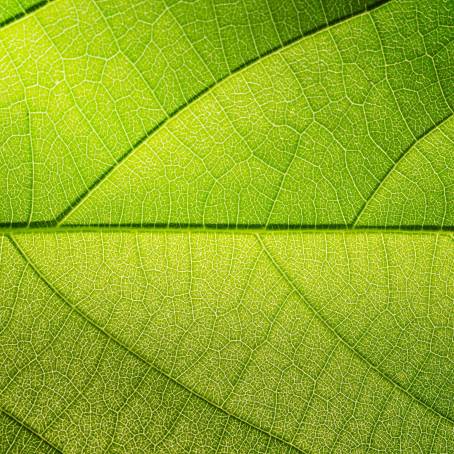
0 0 454 226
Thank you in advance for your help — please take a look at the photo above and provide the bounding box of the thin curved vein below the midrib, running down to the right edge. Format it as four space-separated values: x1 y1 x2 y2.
256 234 454 424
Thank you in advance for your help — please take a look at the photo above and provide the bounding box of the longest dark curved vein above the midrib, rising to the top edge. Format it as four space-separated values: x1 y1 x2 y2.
53 0 391 226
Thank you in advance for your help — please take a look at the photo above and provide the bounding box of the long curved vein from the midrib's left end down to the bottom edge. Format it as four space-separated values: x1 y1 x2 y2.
8 235 304 454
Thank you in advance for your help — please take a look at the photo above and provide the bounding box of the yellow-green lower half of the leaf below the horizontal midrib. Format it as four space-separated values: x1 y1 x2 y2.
0 232 454 453
